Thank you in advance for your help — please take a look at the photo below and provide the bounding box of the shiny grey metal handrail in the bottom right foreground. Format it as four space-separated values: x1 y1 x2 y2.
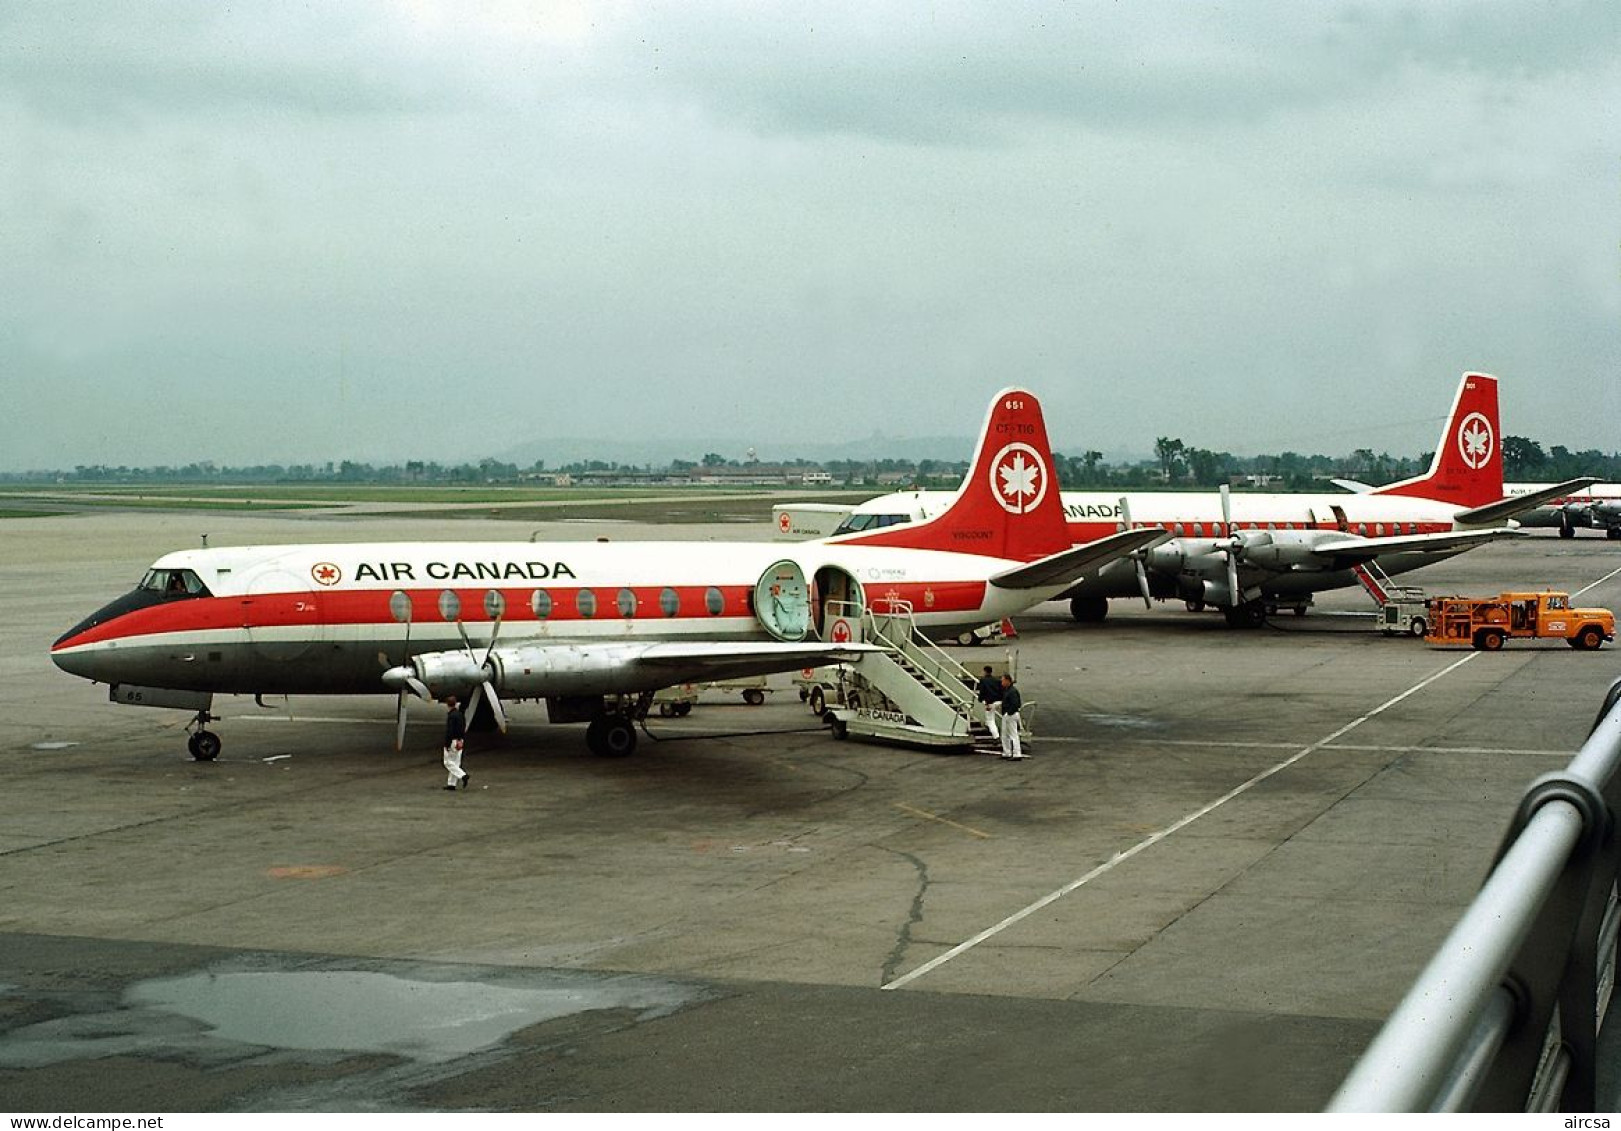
1328 681 1621 1112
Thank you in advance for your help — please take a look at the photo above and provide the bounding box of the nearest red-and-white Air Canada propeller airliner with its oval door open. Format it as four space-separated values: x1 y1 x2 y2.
50 389 1164 760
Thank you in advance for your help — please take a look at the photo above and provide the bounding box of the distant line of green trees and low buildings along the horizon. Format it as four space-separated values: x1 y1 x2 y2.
0 436 1621 491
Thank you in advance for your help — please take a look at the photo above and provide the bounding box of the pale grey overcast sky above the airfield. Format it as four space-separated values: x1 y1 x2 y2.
0 0 1621 470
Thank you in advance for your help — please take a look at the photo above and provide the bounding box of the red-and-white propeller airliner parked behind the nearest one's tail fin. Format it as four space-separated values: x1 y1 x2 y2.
833 373 1592 627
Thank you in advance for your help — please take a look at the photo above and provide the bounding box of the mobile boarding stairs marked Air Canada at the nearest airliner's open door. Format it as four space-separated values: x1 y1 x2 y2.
828 601 1033 753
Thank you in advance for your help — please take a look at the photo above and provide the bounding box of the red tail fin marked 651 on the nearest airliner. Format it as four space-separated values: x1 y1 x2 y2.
840 389 1073 562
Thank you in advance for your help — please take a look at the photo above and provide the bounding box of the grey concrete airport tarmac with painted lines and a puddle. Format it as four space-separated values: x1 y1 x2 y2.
0 514 1621 1113
